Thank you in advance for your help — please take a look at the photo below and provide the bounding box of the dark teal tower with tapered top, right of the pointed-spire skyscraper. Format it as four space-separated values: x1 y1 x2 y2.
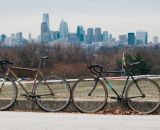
76 25 85 42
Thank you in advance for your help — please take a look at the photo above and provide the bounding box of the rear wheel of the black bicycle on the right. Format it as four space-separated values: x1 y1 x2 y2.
126 78 160 114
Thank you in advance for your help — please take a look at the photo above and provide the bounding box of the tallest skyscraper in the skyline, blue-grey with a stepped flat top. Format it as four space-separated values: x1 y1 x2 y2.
41 14 50 43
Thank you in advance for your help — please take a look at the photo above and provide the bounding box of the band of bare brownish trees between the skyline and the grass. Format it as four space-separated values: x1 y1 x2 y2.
0 43 160 78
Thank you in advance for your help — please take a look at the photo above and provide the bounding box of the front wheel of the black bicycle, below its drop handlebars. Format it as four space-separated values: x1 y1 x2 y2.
72 79 108 113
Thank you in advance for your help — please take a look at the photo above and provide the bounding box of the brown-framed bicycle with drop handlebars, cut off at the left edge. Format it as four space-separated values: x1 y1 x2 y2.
0 56 71 112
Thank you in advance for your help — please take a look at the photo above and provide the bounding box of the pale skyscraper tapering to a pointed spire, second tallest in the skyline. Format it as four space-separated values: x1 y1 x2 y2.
59 19 68 41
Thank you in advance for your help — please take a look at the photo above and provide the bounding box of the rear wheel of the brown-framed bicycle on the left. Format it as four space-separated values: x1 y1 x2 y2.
35 76 71 112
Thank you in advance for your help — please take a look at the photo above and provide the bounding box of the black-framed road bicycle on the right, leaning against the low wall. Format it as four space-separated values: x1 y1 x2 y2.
72 62 160 114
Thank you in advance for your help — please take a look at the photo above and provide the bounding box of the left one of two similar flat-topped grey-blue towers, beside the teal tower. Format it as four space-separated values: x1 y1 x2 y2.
86 28 94 44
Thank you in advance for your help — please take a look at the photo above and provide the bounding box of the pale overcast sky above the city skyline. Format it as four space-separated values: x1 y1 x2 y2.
0 0 160 40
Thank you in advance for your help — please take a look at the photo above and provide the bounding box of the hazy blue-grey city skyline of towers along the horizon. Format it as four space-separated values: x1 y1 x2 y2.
0 13 159 49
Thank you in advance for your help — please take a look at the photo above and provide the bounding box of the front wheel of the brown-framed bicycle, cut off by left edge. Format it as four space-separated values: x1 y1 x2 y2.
0 75 18 111
